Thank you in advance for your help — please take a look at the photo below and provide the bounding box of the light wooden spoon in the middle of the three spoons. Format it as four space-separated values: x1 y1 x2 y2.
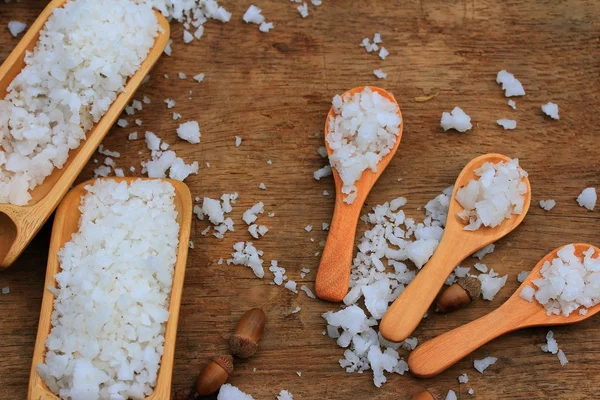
379 154 531 342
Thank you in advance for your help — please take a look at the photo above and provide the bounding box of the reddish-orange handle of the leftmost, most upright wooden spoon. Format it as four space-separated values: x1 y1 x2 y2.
315 198 362 303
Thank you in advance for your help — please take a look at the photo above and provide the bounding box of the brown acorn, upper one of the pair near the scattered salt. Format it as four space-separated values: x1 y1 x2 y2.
229 308 265 358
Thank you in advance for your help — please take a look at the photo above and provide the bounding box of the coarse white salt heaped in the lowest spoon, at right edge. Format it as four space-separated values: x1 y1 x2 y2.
532 244 600 317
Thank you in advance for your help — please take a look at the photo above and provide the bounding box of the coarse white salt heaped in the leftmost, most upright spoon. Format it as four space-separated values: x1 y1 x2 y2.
325 87 402 204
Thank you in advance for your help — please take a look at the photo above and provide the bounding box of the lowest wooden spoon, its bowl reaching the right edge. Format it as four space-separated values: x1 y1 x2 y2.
408 243 600 378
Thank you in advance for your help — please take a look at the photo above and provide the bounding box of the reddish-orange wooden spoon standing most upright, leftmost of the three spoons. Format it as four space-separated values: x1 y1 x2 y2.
315 86 404 302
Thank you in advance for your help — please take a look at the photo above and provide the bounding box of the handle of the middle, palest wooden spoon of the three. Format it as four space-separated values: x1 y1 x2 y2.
379 233 472 342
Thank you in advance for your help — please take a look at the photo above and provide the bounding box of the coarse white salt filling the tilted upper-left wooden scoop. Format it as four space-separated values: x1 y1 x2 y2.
0 0 159 205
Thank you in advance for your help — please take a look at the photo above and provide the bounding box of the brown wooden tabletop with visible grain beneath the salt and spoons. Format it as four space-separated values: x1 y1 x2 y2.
0 0 600 399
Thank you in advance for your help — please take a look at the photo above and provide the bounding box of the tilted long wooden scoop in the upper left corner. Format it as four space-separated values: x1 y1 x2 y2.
0 0 170 268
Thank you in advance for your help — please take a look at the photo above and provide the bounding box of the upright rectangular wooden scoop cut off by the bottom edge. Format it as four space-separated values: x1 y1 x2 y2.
27 177 193 400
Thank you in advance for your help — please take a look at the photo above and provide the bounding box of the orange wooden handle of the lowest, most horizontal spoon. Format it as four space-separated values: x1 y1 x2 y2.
408 303 523 378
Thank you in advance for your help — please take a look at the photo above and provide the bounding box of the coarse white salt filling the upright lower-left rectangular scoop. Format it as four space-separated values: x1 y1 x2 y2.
36 180 179 399
